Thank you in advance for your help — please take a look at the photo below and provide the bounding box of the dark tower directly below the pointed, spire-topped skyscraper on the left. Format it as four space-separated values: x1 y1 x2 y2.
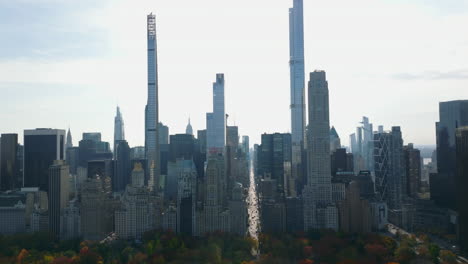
112 140 132 192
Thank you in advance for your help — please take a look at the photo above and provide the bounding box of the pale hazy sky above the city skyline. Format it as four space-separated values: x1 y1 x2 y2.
0 0 468 146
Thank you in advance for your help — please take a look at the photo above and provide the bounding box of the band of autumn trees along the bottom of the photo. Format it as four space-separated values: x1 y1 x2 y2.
0 231 457 264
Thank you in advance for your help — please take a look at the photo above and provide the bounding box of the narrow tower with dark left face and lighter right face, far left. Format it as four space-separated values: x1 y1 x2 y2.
48 160 69 237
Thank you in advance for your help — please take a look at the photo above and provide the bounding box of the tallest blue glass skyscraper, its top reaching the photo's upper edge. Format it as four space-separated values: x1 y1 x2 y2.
289 0 305 196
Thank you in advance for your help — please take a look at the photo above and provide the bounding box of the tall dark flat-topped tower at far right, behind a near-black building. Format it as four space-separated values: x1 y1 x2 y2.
436 100 468 209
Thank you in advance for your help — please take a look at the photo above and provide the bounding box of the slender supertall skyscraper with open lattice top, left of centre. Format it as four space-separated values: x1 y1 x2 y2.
145 13 160 190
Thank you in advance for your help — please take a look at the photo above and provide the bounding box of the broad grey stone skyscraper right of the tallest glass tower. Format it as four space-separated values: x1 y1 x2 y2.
303 71 338 230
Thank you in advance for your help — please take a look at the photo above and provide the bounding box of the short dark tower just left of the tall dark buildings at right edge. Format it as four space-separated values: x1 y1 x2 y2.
403 144 421 198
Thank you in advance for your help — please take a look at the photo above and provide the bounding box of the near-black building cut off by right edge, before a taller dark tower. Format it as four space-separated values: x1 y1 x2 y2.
455 127 468 253
